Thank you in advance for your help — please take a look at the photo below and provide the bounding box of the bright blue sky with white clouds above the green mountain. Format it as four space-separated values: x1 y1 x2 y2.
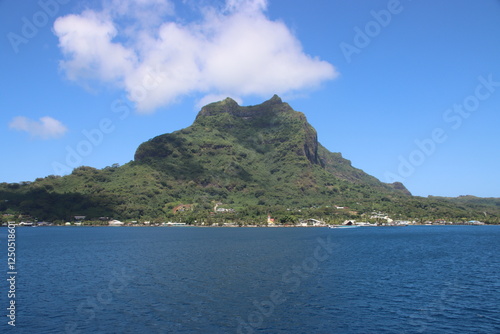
0 0 500 197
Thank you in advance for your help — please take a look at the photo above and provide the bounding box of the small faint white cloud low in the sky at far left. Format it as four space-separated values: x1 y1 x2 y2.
9 116 68 139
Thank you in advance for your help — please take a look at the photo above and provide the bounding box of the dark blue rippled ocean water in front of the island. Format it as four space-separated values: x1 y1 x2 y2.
0 226 500 334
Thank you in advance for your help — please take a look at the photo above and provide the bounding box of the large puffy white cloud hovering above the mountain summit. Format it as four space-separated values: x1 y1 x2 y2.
54 0 337 112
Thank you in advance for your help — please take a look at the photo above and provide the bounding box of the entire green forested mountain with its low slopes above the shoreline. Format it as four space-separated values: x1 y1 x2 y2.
0 95 500 221
